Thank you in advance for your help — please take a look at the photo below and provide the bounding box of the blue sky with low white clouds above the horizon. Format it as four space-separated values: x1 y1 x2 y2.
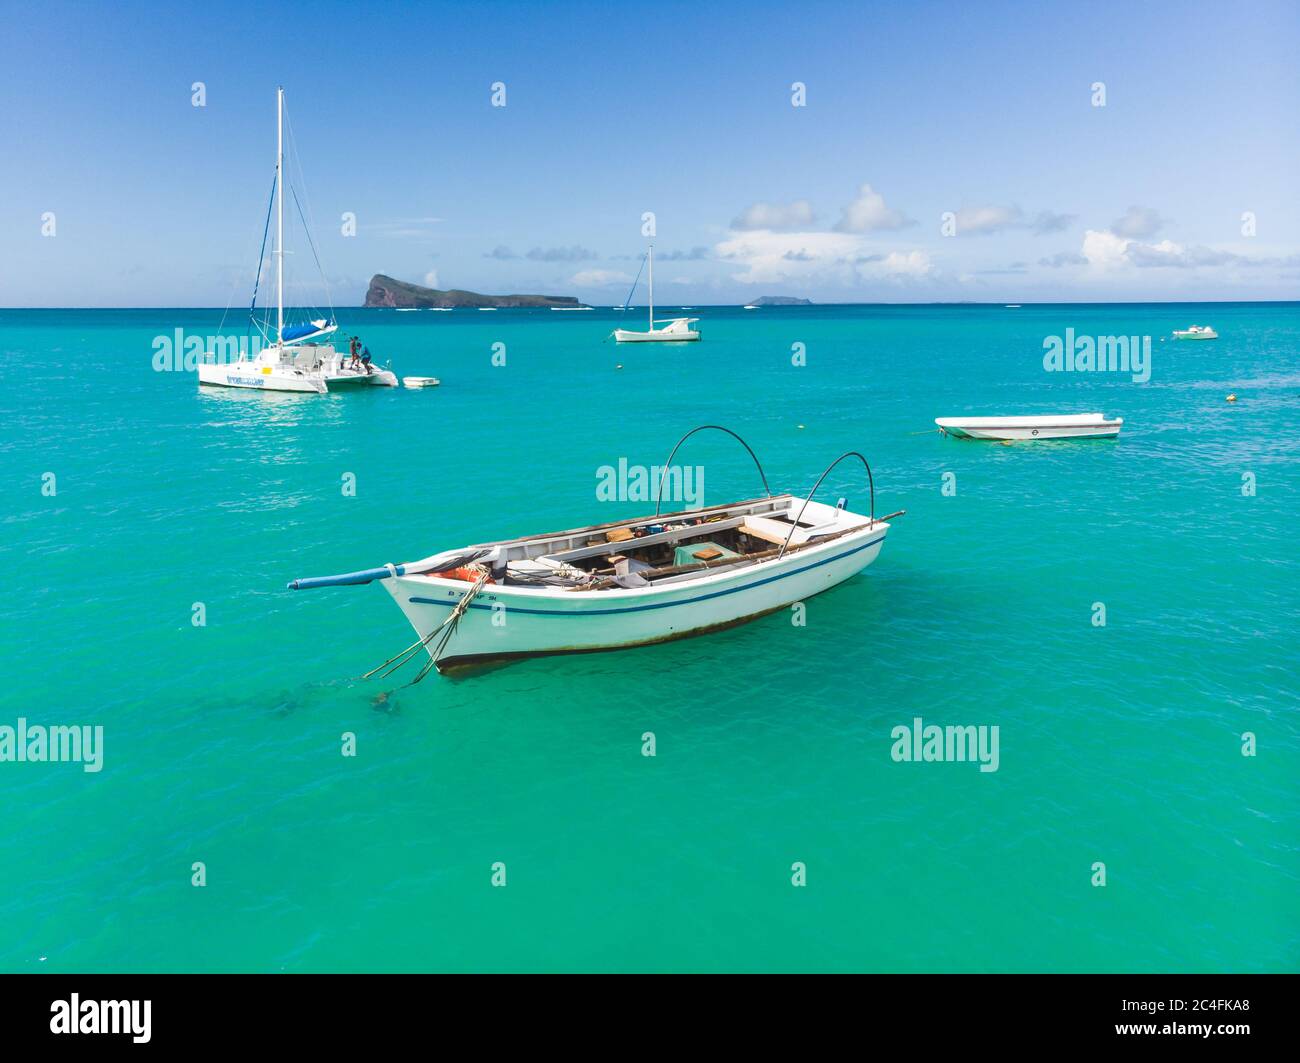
0 0 1300 307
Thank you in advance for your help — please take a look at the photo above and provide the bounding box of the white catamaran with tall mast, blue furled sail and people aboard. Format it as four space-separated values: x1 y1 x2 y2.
199 88 398 395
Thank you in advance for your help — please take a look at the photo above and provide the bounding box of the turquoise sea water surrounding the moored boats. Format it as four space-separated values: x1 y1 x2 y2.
0 304 1300 971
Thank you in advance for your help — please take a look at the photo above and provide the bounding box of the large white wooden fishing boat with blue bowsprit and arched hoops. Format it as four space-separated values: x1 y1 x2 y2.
289 425 902 678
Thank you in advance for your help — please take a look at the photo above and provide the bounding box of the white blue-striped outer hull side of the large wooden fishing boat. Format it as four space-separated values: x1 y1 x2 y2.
384 522 889 672
